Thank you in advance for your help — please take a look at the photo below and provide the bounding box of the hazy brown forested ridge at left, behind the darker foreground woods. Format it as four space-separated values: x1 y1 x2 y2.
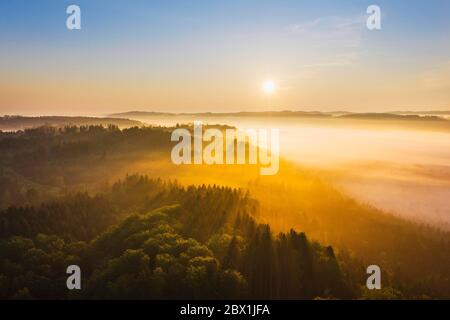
0 125 171 209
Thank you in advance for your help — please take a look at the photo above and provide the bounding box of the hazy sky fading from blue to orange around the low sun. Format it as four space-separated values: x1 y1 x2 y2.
0 0 450 114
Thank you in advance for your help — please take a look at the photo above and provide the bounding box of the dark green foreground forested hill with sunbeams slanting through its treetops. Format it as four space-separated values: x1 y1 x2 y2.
0 176 357 299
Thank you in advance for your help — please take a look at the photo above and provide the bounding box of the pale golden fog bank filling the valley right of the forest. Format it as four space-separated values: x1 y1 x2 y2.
107 112 450 229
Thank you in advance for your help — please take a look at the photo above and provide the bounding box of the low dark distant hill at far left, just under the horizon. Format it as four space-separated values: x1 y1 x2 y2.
0 116 142 131
